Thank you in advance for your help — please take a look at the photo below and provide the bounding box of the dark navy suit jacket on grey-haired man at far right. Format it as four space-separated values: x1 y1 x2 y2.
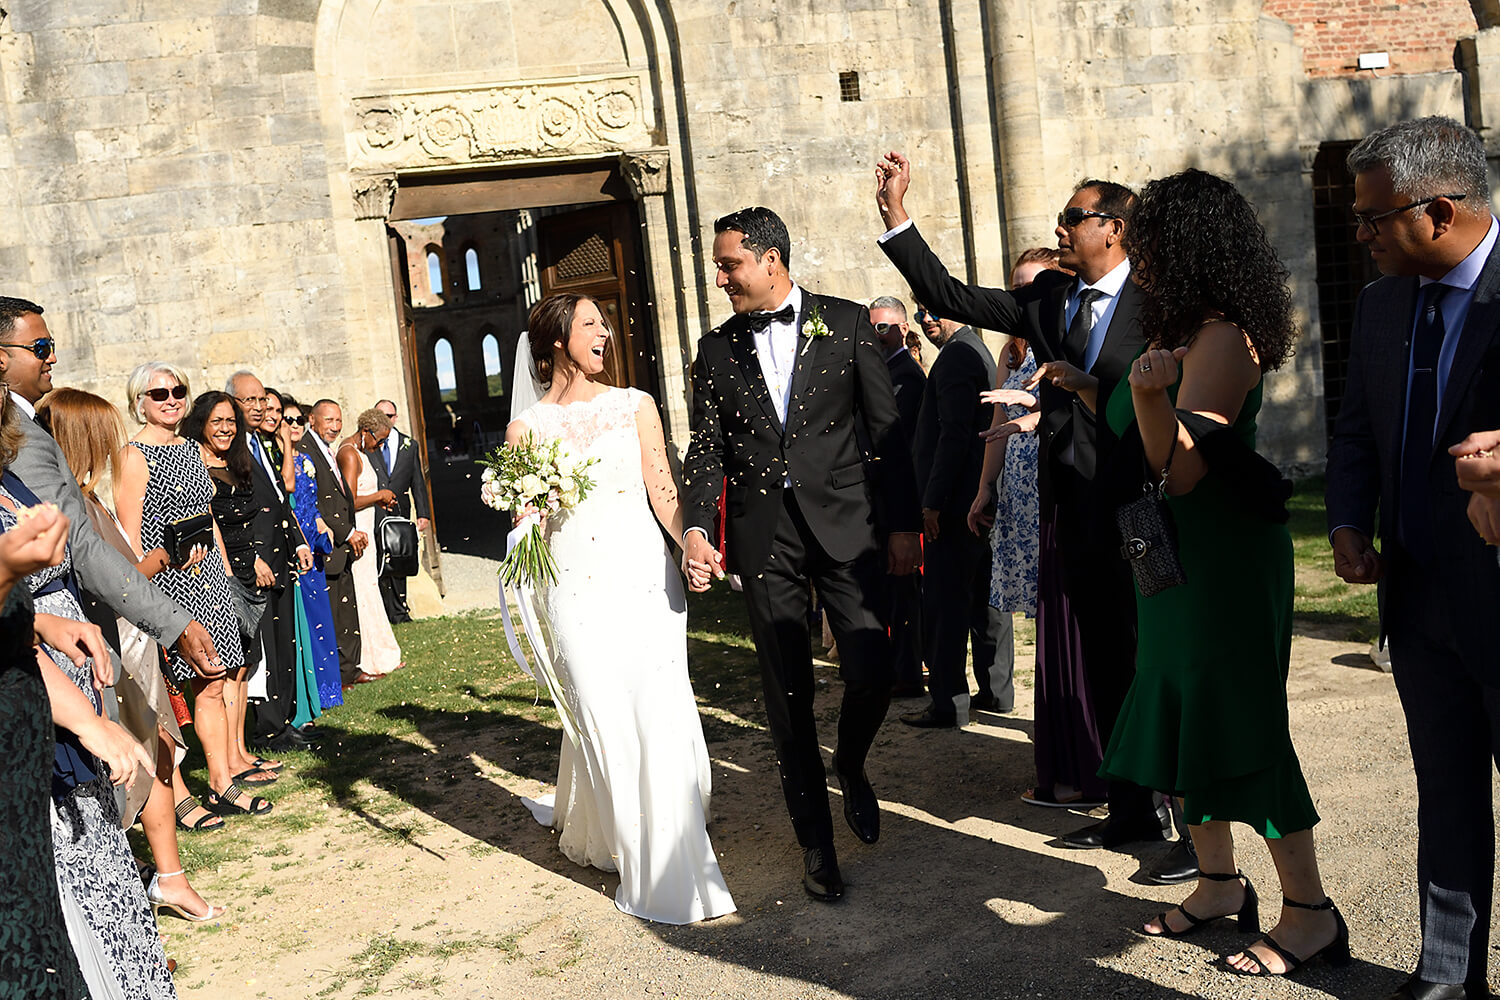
1326 244 1500 687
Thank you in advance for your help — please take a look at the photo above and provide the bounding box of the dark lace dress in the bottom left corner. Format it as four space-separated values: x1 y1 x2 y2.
0 583 89 1000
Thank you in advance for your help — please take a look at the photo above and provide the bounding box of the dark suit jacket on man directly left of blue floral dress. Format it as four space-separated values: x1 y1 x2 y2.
912 326 995 517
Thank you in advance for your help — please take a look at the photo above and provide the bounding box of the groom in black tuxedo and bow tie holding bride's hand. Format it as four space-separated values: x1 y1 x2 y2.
683 208 921 901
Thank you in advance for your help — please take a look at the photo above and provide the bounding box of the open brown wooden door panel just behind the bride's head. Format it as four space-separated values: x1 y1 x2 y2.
537 204 660 397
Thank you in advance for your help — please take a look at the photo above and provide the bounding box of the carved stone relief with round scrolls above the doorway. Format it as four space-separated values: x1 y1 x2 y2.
350 75 653 169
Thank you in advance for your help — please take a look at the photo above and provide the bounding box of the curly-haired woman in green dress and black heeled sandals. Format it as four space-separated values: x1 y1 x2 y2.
1100 169 1349 975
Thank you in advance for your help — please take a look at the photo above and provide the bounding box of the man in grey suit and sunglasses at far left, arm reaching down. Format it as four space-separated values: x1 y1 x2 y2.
0 297 224 678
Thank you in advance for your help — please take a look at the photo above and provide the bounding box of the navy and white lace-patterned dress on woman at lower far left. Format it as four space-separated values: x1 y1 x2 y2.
0 487 177 1000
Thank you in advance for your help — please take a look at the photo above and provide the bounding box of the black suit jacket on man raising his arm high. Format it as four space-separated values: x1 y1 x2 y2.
881 225 1146 502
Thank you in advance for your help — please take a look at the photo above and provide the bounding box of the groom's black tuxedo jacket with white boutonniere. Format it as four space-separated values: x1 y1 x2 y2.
683 288 921 574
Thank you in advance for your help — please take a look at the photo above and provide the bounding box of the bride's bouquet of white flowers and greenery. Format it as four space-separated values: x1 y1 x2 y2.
479 435 596 588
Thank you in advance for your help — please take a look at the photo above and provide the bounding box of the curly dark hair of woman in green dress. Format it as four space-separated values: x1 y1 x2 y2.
1125 169 1299 372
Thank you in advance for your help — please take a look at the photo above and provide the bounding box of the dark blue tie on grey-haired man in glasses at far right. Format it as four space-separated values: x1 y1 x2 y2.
1397 282 1449 562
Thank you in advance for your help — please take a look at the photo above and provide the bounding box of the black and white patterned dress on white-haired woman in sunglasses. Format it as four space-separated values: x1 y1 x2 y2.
131 441 245 688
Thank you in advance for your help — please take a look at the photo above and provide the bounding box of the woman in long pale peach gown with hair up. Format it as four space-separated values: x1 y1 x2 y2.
338 409 407 676
